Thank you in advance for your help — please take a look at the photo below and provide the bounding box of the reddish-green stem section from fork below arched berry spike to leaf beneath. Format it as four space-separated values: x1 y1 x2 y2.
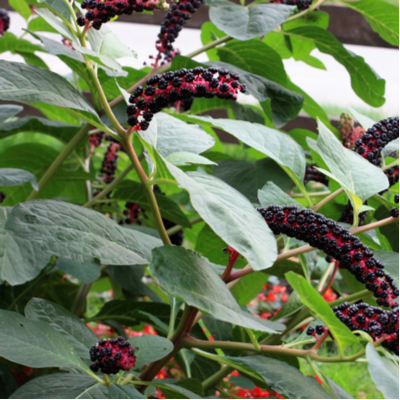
124 136 171 245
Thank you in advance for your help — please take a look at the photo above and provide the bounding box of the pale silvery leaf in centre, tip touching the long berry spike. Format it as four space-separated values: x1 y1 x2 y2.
167 163 276 270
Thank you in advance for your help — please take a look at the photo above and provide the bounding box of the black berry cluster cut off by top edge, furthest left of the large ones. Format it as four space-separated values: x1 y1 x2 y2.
77 0 168 29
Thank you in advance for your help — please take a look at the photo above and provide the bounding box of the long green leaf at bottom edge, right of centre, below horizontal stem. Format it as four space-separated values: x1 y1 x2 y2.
197 356 332 399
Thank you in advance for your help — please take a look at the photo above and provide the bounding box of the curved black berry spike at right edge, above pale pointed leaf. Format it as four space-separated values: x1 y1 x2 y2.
354 117 399 167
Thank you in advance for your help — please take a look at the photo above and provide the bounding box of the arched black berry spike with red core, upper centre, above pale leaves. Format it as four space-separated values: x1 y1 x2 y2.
126 67 246 131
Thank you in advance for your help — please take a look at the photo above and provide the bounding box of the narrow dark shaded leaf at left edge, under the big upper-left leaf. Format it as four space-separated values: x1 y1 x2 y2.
0 117 80 143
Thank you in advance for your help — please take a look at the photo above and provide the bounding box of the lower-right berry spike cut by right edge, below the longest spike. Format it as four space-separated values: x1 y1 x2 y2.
333 302 399 355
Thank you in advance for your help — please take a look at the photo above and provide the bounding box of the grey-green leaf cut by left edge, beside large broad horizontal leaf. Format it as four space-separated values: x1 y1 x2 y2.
0 207 50 285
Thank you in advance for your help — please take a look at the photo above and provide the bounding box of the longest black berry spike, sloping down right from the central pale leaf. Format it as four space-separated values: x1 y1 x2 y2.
257 206 399 307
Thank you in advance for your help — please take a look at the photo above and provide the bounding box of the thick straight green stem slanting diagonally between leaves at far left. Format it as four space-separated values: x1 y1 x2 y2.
26 124 91 201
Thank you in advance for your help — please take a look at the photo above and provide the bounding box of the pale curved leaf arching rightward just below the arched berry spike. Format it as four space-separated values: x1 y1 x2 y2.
180 115 306 182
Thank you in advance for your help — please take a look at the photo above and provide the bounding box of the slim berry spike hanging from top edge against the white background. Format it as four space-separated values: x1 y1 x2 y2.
154 0 202 65
